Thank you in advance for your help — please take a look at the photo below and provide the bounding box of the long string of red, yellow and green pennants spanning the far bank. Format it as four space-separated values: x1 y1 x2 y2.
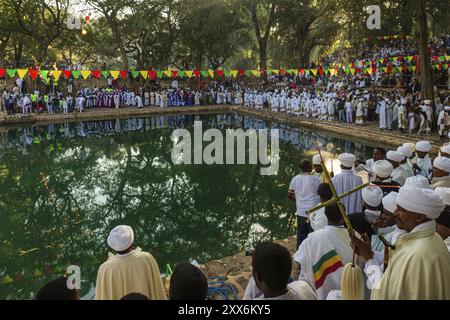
0 55 450 83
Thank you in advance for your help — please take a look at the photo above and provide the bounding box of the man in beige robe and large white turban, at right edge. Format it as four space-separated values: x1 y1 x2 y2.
352 183 450 300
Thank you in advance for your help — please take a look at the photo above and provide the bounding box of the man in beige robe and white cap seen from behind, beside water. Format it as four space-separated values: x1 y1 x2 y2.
95 226 167 300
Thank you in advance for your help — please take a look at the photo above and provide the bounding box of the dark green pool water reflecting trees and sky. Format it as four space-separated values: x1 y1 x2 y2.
0 114 371 299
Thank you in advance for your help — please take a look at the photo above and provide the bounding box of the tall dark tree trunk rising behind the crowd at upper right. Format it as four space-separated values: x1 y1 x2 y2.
417 0 434 101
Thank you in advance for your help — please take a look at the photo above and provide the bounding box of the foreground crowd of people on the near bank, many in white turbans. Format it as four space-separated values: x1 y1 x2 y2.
37 141 450 300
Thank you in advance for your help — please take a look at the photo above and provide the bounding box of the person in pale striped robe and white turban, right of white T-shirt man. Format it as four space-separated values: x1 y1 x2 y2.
332 153 363 214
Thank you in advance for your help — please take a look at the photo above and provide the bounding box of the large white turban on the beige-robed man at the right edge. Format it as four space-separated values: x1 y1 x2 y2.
397 185 445 220
